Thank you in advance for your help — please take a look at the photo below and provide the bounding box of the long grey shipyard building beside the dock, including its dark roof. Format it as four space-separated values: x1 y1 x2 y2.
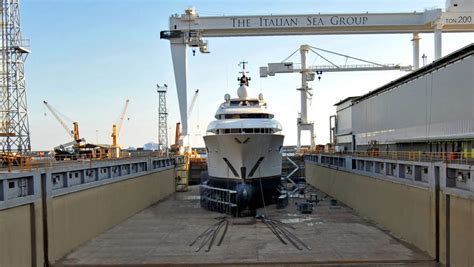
331 44 474 155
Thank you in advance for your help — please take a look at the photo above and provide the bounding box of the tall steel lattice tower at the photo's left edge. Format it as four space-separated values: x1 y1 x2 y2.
0 0 31 163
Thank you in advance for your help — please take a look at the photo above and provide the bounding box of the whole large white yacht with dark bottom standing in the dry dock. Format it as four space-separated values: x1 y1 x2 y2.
204 67 284 214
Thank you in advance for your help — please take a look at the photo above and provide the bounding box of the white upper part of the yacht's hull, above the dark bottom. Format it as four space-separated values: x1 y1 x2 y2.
204 134 284 180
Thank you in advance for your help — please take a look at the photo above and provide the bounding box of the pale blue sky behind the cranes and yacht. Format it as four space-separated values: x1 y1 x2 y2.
21 0 474 150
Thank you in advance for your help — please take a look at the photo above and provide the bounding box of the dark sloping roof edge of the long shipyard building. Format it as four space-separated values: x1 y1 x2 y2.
352 43 474 103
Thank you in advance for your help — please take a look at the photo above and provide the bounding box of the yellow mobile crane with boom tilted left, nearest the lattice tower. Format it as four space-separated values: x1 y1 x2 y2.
43 101 93 160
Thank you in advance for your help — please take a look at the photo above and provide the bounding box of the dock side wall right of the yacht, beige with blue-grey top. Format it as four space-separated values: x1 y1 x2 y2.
305 155 474 266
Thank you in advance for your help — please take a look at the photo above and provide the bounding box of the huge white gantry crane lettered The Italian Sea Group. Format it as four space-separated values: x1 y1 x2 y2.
160 0 474 139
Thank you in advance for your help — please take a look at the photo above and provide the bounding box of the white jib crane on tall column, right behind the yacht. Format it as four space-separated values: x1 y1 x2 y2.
260 44 412 149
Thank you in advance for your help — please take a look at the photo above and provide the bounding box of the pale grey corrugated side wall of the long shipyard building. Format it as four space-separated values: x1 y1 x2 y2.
350 56 474 147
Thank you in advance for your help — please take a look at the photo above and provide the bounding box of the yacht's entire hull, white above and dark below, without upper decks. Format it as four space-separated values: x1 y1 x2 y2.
203 134 284 216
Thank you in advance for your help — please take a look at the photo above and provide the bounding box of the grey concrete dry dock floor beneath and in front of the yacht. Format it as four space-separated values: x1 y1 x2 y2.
58 187 436 266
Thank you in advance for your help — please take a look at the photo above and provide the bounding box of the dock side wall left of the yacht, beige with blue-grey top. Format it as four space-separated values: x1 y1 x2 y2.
0 158 175 267
